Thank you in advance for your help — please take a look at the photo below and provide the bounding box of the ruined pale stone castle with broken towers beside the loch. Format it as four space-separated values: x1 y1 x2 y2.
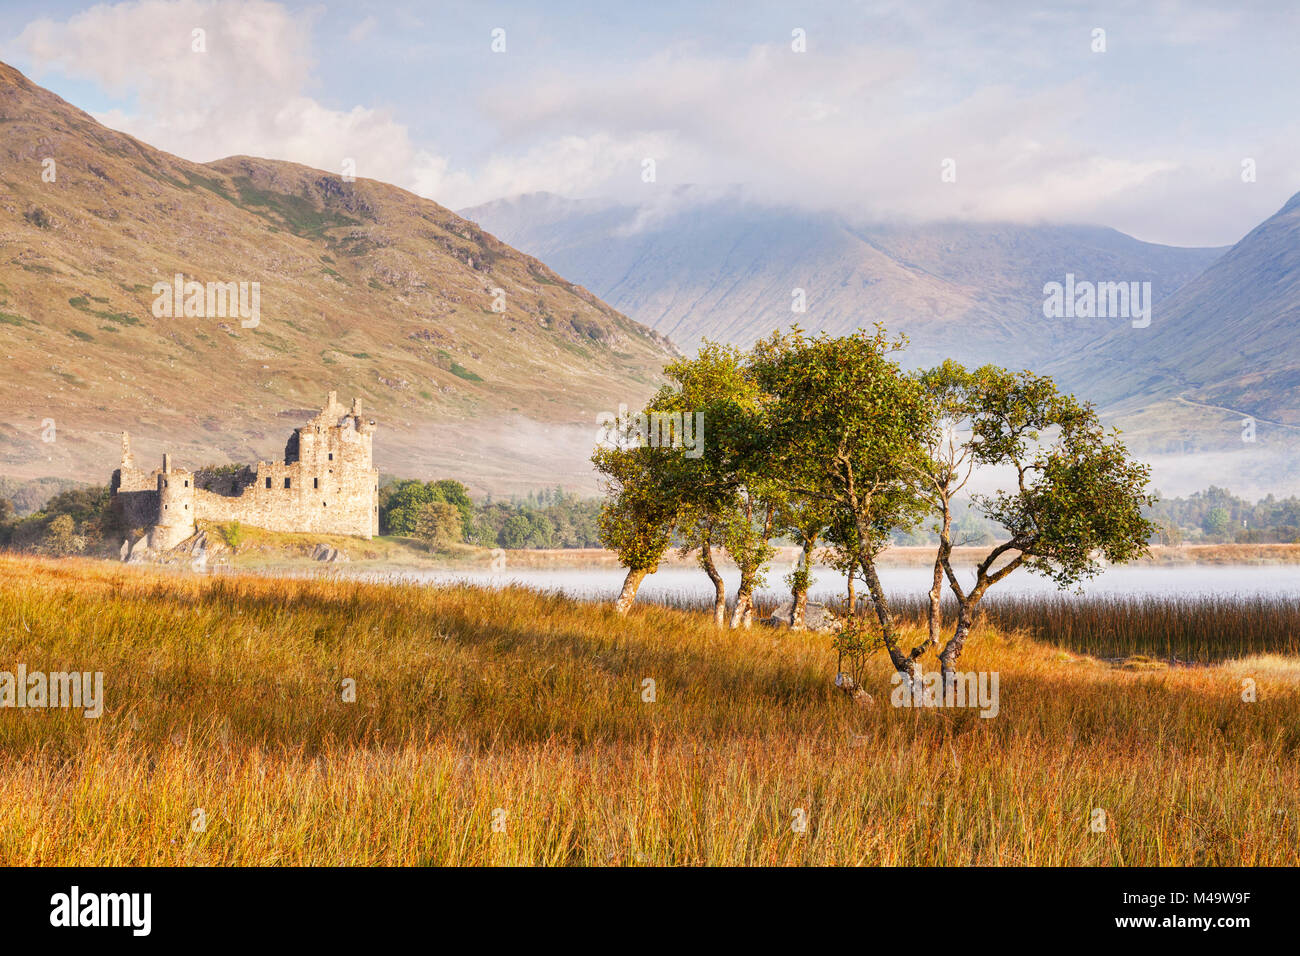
112 392 380 551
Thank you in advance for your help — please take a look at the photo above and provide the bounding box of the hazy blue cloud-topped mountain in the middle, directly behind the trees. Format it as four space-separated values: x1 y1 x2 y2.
462 189 1222 365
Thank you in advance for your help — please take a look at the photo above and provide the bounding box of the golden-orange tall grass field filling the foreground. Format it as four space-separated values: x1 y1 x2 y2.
0 557 1300 866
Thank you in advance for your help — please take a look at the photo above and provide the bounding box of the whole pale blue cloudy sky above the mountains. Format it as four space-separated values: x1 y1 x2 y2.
0 0 1300 246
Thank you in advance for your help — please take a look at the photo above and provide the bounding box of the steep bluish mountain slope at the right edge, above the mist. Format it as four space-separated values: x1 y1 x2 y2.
1047 195 1300 496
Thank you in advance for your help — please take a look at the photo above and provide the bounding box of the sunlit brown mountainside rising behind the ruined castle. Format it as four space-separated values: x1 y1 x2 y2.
0 64 676 492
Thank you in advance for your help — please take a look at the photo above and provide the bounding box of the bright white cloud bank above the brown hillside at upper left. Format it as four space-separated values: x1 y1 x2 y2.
7 0 702 207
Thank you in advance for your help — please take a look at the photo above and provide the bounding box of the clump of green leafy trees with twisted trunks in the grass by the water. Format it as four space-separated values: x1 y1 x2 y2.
592 325 1154 674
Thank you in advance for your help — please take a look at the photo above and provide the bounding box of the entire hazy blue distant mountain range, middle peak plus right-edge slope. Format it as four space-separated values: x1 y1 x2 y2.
462 189 1300 497
